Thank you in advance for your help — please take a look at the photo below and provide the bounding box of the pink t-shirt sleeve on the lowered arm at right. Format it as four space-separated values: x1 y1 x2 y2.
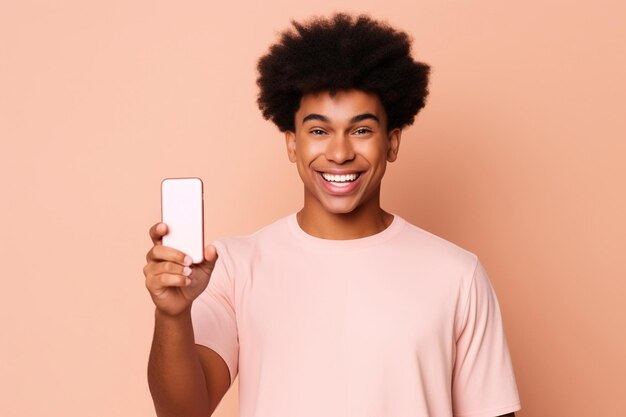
452 259 521 417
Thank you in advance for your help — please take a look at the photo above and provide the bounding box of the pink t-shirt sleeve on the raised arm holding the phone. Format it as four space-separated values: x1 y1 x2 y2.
191 241 239 384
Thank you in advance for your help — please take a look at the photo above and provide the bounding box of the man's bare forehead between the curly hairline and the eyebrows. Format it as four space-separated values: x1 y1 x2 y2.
296 90 385 123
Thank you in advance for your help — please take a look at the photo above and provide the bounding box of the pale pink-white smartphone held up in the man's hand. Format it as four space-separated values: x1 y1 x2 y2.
161 177 204 264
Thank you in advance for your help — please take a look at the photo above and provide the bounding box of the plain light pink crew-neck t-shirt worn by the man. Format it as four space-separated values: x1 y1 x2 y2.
191 213 520 417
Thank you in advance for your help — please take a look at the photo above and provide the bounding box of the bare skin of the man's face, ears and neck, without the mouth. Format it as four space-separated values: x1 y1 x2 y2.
285 90 402 240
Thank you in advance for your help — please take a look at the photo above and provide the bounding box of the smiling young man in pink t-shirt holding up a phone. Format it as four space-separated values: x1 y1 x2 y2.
144 14 520 417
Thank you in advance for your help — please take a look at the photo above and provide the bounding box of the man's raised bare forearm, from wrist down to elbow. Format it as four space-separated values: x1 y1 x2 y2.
148 309 211 417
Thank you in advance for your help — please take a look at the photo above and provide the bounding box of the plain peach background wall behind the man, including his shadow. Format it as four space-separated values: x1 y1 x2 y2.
0 0 626 417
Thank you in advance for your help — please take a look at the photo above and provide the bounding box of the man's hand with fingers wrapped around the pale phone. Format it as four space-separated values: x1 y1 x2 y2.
143 223 218 316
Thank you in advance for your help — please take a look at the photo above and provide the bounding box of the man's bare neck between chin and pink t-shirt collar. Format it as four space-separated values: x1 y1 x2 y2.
296 191 393 240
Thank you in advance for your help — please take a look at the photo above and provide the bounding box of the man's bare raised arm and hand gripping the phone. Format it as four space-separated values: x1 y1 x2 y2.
143 223 230 417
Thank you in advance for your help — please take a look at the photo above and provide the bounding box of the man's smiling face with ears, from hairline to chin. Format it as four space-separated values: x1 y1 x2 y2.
285 90 401 214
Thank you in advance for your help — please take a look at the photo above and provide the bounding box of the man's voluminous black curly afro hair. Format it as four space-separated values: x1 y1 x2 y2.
257 13 430 132
